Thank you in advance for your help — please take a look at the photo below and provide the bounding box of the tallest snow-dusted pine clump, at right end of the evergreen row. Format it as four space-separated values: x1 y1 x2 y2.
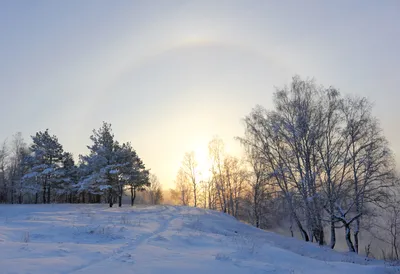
77 122 148 207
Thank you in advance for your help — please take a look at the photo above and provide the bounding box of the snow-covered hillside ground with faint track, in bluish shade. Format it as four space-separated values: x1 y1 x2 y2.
0 205 400 274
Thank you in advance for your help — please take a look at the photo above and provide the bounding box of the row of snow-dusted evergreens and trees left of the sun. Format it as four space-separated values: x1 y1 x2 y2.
0 122 152 207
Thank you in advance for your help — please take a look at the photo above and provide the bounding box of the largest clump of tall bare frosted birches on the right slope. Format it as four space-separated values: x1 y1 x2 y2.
240 77 393 252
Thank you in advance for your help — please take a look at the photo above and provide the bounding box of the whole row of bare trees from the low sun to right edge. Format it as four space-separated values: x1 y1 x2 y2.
172 77 400 259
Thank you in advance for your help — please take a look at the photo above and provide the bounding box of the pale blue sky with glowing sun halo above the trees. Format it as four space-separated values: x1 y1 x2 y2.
0 0 400 187
